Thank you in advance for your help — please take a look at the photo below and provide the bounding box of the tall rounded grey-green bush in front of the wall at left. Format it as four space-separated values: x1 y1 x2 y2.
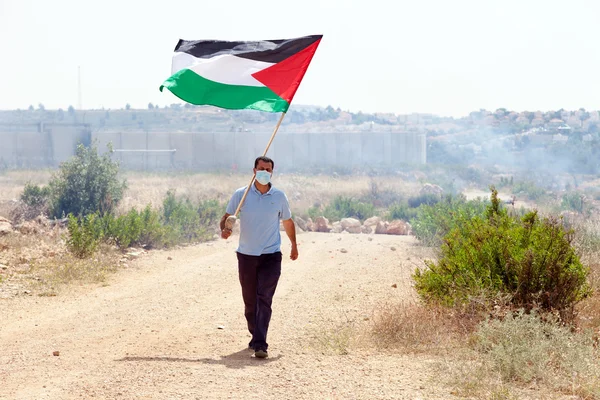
49 144 126 218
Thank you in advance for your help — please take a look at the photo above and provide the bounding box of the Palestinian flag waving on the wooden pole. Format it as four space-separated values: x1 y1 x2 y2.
160 35 322 112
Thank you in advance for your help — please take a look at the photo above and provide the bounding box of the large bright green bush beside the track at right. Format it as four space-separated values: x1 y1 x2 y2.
413 188 591 316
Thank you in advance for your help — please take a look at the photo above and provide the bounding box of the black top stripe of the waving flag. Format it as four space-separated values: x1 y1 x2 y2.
175 35 323 63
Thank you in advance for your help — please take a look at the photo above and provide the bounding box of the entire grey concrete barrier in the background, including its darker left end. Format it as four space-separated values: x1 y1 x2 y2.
0 124 426 171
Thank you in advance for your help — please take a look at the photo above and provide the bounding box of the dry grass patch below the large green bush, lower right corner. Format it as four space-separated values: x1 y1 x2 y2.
371 303 600 399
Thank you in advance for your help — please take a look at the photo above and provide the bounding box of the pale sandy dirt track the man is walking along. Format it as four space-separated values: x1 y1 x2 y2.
0 233 452 400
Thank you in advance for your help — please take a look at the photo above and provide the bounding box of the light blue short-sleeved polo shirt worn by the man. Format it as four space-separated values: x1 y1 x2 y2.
226 183 292 256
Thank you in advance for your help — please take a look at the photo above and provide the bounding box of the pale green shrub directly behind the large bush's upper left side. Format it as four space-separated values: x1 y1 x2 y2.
411 195 487 246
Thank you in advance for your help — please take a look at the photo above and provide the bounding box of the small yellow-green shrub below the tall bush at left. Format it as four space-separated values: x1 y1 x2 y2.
67 214 104 258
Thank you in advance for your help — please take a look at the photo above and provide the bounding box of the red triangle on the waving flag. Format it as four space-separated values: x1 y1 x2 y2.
252 39 321 103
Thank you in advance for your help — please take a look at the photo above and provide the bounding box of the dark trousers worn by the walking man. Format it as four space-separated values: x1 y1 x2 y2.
237 252 281 350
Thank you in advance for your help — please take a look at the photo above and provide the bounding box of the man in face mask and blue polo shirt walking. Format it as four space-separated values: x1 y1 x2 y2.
220 157 298 358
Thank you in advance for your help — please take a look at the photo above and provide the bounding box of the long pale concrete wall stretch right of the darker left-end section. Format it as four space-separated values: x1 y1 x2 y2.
92 132 426 171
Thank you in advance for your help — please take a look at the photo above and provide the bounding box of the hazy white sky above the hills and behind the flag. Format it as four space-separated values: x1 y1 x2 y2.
0 0 600 116
